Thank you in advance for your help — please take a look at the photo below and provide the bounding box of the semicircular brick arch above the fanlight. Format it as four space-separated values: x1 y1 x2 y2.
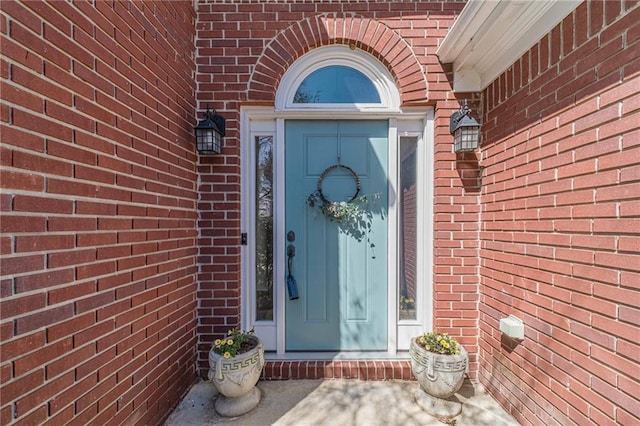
248 14 428 105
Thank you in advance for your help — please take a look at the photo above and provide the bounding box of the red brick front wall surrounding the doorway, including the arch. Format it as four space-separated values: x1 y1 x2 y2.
196 0 479 374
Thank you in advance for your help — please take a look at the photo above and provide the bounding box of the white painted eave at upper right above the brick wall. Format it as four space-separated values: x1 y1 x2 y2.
436 0 582 92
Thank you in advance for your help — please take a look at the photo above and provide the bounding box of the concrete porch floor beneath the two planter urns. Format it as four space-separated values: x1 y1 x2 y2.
165 379 518 426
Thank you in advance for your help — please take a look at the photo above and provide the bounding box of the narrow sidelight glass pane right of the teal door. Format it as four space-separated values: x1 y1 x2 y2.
398 138 418 320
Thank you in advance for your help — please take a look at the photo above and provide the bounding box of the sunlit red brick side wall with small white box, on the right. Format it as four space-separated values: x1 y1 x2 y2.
479 0 640 425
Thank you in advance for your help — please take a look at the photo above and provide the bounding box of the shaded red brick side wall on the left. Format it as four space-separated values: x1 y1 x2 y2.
0 0 197 425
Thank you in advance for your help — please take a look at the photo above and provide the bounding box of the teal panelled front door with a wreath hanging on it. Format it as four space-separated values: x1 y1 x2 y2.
285 120 388 351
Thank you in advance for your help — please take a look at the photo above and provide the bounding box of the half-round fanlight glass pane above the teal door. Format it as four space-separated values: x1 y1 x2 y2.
293 65 380 104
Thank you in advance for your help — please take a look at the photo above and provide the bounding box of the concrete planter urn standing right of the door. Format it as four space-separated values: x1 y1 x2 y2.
409 338 469 417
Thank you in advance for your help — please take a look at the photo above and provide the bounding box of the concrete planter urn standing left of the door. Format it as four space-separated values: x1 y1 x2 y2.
208 335 264 417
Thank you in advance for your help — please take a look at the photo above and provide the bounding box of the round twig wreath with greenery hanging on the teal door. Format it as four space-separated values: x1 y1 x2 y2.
307 163 370 225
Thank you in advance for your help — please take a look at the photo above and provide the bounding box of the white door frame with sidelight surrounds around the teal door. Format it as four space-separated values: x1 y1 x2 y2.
240 106 434 359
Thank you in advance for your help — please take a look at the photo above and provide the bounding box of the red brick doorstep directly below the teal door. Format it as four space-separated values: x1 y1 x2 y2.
260 360 415 380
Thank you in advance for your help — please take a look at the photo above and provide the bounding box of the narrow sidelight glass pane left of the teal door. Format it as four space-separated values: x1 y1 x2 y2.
255 136 273 321
